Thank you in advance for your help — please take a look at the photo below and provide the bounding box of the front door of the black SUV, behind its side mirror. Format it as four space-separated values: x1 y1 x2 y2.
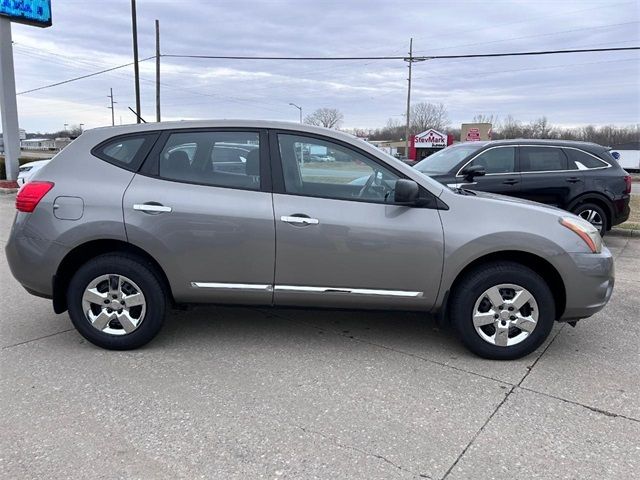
459 145 521 196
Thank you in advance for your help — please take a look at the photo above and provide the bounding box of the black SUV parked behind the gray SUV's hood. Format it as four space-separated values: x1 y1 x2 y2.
415 140 631 235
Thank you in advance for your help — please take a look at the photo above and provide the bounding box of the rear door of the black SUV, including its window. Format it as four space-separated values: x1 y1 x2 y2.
519 145 584 208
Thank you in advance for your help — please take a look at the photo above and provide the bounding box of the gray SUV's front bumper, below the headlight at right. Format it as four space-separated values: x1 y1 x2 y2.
559 246 615 321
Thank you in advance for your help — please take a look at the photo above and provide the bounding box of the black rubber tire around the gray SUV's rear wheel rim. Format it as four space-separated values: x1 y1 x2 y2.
67 253 167 350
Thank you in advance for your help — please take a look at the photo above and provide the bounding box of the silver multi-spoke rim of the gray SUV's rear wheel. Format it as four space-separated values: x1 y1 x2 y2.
82 273 147 336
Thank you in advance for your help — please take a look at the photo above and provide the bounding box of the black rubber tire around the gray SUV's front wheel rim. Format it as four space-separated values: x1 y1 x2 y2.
449 261 556 360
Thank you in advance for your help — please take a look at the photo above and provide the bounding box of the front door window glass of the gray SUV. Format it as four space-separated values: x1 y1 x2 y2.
278 134 398 203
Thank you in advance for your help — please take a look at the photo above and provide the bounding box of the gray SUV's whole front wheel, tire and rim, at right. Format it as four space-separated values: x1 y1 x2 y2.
450 262 555 360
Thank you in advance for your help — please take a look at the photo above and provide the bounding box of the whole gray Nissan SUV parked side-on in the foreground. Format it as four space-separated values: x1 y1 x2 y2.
6 121 614 359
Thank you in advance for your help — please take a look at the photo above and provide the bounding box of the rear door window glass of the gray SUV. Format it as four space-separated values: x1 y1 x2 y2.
159 132 260 190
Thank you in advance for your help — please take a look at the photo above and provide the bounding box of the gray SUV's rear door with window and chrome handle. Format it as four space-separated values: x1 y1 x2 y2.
123 129 275 304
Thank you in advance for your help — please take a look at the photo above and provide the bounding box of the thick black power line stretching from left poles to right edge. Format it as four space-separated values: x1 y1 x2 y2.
162 46 640 61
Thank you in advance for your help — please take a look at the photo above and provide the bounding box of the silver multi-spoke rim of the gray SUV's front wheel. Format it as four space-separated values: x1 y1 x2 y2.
472 283 539 347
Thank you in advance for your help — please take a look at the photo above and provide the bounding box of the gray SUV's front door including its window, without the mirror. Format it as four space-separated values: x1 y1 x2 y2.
271 133 443 309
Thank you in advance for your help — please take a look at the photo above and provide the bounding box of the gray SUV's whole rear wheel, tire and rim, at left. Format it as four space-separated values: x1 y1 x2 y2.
67 254 166 350
